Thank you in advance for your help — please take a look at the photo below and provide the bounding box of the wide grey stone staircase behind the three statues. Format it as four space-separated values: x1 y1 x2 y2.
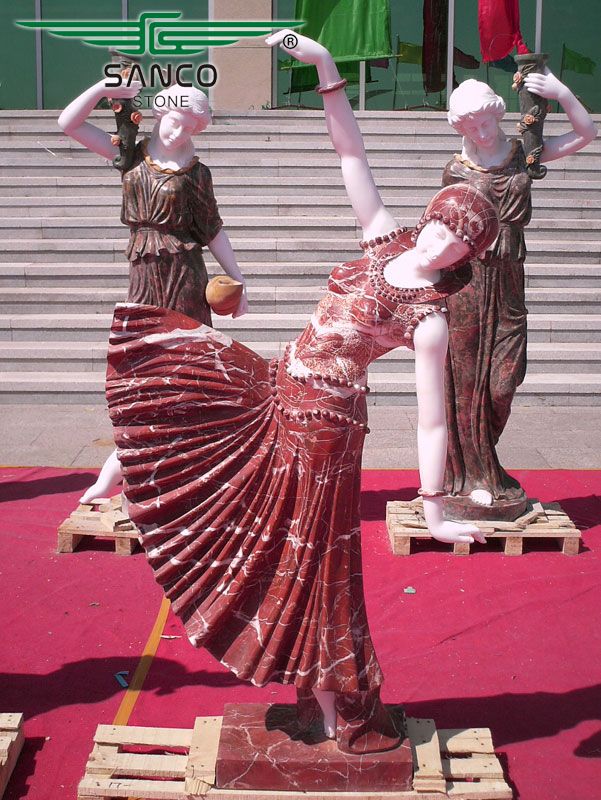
0 111 601 405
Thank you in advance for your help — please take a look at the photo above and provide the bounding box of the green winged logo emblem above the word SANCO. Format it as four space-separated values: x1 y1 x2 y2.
16 11 304 56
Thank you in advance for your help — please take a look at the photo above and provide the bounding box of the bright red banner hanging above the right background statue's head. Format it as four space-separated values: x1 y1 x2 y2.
478 0 529 61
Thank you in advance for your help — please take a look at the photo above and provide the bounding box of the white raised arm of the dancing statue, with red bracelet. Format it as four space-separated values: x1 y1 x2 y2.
266 30 397 239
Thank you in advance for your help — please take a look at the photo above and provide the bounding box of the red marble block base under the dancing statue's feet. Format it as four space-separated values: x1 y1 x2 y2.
216 703 413 792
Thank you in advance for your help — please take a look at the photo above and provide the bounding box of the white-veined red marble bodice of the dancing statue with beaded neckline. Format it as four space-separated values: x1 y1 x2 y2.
288 231 471 386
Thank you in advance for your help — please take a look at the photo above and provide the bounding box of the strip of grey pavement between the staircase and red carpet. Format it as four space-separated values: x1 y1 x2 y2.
0 405 601 469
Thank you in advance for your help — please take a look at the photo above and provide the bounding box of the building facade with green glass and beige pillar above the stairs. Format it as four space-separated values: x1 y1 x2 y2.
0 0 601 112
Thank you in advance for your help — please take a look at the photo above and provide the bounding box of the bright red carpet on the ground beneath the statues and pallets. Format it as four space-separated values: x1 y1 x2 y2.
0 469 601 800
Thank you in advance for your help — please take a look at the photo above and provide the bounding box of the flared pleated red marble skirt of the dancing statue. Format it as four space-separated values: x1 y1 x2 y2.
107 304 382 693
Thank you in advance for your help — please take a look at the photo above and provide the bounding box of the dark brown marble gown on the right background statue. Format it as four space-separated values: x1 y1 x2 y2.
443 140 532 499
